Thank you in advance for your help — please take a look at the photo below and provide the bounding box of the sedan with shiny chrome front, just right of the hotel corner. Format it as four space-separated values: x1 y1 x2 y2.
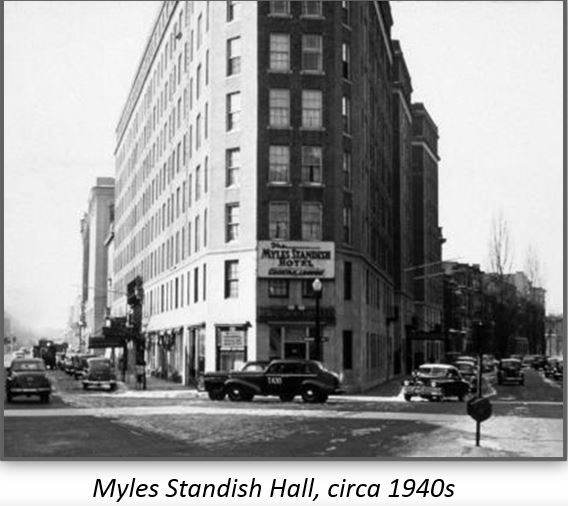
402 364 470 401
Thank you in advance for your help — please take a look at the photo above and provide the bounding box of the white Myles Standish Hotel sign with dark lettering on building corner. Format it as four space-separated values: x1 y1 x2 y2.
258 241 335 279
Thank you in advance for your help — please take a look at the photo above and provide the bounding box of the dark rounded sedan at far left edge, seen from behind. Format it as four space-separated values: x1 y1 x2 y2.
6 358 52 403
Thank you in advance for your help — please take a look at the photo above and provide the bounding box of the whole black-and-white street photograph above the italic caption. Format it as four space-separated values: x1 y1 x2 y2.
2 0 566 474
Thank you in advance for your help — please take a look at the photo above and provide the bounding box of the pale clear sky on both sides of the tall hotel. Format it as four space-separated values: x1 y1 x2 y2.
4 1 564 328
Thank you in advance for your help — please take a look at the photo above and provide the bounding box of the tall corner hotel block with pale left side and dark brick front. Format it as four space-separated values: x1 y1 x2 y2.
111 0 444 388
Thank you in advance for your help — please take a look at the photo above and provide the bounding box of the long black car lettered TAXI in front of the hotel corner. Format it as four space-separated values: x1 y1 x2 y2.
204 360 341 403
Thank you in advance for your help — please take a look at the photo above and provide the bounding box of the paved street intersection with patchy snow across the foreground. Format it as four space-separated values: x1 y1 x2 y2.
5 370 563 458
